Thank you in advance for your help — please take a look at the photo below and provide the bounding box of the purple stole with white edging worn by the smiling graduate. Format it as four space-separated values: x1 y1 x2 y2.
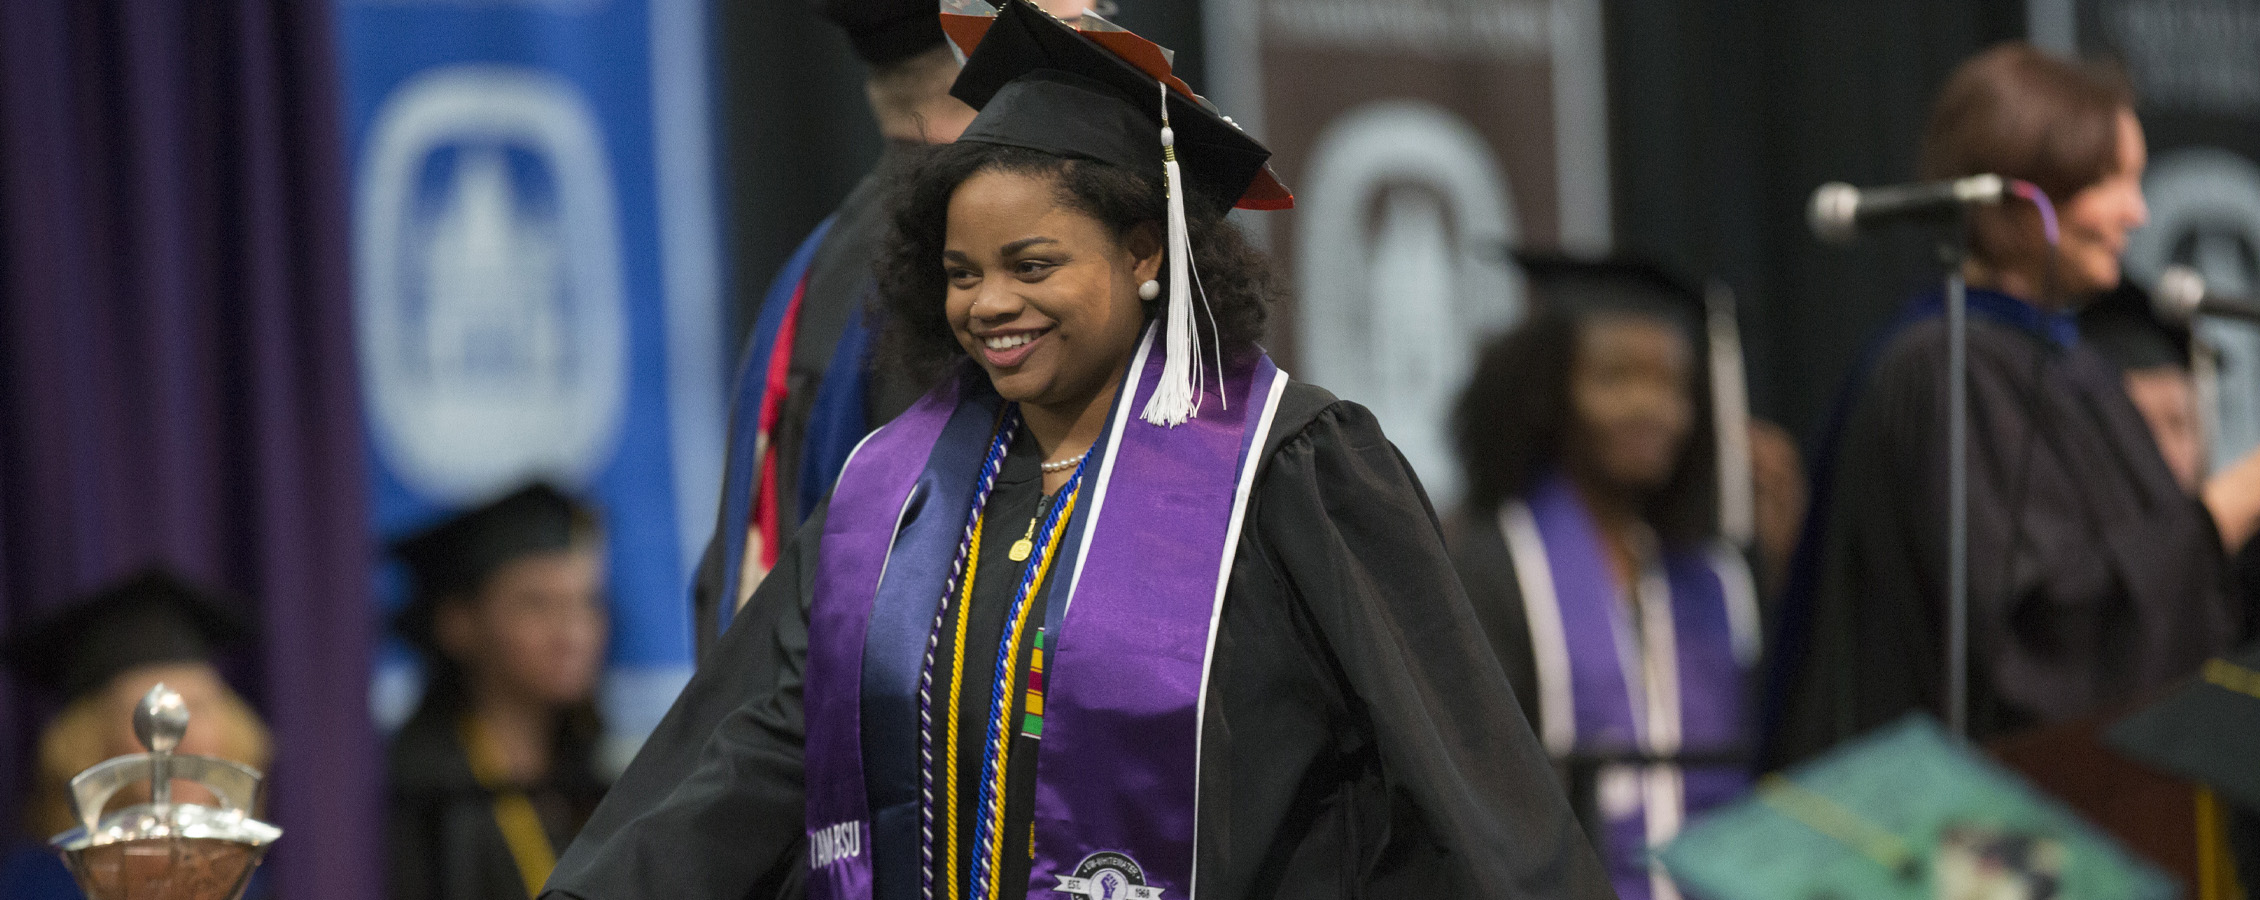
805 330 1286 900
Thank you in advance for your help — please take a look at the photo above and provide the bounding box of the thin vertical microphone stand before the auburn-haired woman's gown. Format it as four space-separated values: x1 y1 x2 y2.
1939 215 1971 739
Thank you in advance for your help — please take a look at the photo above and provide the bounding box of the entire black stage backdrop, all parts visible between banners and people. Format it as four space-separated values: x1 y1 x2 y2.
716 0 2070 436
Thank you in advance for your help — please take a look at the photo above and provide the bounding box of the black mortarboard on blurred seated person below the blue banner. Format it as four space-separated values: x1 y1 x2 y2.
393 482 597 647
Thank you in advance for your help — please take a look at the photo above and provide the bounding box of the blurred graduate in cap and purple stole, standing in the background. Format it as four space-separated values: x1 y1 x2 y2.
1453 253 1761 898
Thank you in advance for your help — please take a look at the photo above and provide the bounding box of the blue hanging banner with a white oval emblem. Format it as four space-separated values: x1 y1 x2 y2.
339 0 725 764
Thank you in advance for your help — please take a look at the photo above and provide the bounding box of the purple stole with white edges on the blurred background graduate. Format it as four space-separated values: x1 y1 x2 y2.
1498 475 1758 900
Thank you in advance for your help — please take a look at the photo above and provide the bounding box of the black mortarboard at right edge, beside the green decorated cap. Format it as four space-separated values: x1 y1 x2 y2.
2104 644 2260 810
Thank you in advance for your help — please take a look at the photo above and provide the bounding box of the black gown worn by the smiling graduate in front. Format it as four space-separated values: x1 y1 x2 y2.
545 384 1611 900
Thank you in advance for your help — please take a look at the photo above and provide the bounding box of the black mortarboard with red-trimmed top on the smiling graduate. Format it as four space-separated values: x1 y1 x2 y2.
942 0 1295 210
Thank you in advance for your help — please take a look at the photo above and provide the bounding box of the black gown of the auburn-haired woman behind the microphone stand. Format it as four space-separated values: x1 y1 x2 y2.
1767 309 2240 767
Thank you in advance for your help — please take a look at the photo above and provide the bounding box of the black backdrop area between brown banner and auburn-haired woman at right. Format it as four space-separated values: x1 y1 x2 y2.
1609 0 2025 439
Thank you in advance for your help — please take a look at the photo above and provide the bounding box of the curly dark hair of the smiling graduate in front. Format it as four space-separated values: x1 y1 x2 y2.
875 140 1279 384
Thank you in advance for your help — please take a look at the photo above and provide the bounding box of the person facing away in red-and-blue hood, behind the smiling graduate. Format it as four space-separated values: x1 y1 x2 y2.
692 0 1102 656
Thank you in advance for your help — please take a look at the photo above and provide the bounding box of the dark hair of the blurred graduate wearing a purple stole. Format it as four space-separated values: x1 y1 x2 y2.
1451 310 1718 545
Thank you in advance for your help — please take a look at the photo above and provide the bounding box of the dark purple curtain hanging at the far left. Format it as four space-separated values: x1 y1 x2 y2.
0 0 382 900
